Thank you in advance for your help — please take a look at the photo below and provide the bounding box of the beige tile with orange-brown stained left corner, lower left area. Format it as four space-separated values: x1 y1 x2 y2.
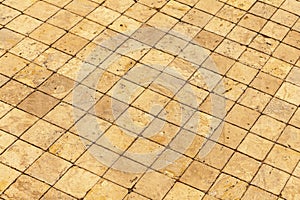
49 132 90 162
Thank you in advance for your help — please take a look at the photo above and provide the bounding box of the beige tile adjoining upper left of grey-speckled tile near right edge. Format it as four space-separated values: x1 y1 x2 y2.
238 88 272 112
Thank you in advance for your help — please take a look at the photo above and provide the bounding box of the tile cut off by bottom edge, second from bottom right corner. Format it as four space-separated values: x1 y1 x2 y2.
242 186 277 200
